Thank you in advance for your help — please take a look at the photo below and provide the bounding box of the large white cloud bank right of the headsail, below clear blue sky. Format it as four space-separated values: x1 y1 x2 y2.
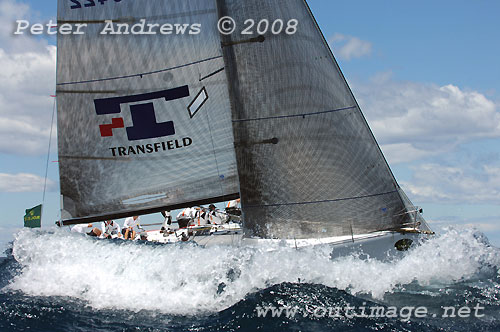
353 73 500 164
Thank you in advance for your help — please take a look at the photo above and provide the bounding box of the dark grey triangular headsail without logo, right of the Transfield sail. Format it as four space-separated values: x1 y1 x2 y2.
218 0 407 238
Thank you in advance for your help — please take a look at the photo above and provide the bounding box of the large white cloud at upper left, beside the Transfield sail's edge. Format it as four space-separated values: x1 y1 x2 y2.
0 0 56 155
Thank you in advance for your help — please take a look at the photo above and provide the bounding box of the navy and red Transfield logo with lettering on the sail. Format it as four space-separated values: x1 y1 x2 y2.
94 85 192 157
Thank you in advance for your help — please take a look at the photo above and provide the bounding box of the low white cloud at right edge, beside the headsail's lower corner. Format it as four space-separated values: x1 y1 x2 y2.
401 164 500 205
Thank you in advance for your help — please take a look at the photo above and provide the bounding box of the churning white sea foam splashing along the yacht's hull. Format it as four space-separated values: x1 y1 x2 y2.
7 229 500 314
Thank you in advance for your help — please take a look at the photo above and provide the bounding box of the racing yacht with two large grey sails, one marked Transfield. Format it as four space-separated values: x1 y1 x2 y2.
57 0 430 251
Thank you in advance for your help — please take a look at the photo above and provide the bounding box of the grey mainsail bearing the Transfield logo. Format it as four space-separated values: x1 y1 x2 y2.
57 0 238 223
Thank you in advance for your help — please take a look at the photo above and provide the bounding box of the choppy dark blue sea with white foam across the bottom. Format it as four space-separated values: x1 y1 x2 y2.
0 229 500 332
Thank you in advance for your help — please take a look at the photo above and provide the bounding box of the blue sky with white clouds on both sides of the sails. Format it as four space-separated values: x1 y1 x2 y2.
0 0 500 250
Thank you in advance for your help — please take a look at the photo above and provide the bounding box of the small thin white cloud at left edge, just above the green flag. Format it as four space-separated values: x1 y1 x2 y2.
0 173 56 193
